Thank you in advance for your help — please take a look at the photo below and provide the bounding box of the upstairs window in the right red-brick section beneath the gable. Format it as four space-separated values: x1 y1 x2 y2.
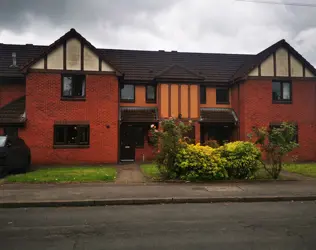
272 81 292 103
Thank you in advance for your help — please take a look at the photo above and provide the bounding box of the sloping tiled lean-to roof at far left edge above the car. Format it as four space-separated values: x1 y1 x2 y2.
0 96 26 125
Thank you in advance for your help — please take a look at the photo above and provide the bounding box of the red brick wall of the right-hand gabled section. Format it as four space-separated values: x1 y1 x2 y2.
239 80 316 161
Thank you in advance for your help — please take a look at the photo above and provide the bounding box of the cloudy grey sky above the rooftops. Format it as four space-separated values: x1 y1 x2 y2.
0 0 316 66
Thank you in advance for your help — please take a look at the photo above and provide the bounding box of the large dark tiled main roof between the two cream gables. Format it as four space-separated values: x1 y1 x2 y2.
100 49 253 82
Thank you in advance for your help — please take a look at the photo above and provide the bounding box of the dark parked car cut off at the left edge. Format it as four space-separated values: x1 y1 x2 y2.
0 136 31 177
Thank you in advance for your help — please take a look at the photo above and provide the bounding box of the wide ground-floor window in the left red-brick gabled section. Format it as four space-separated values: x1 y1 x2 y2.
54 125 90 147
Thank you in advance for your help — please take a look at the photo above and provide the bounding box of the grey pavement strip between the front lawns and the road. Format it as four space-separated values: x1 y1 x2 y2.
0 180 316 208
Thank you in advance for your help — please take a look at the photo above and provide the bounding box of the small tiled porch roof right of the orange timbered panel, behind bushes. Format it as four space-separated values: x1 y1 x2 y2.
200 108 238 123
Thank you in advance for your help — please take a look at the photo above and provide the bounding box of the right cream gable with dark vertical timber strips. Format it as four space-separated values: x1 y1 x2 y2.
248 46 315 77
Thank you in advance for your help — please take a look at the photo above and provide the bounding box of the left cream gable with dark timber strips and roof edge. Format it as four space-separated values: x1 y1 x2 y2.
23 29 120 74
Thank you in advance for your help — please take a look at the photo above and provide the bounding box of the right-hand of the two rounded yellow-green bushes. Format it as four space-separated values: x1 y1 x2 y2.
218 141 261 179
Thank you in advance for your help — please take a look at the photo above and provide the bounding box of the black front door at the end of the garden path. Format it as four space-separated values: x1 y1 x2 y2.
120 125 135 162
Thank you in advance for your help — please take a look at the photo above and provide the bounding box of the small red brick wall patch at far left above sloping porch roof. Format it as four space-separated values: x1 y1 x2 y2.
0 82 25 108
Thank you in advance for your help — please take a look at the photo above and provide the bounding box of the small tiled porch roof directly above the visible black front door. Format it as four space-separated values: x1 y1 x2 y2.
120 107 158 122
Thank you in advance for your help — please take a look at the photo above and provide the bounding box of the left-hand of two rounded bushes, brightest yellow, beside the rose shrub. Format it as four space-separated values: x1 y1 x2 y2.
174 144 227 181
